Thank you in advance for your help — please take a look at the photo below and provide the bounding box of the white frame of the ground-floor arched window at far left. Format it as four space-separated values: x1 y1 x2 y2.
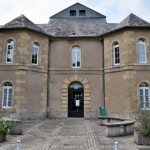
2 83 13 108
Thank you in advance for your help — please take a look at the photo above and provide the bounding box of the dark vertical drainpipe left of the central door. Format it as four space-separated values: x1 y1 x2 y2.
46 38 52 118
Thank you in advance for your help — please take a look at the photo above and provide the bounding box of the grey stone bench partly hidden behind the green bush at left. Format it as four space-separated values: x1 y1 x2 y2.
0 117 22 135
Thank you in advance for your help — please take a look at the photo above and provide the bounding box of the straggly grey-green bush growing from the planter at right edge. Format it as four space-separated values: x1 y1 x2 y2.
136 110 150 136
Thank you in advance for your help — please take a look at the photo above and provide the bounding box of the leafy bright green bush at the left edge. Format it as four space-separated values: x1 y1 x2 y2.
0 120 14 135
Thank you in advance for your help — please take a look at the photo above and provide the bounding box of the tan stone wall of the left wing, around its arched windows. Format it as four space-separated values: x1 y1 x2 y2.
0 30 49 119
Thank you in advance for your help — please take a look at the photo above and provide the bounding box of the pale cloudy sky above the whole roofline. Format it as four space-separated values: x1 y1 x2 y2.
0 0 150 25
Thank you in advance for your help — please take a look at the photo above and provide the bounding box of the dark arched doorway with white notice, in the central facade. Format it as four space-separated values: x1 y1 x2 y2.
68 82 84 118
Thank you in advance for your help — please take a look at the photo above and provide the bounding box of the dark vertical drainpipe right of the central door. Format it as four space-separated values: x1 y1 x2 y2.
100 37 105 108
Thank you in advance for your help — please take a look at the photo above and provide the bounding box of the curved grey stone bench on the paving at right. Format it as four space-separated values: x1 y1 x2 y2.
98 116 135 137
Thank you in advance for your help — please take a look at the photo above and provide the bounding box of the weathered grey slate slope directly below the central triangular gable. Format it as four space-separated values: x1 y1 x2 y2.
47 19 107 37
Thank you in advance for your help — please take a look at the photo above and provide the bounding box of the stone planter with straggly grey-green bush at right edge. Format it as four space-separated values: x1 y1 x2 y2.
134 109 150 145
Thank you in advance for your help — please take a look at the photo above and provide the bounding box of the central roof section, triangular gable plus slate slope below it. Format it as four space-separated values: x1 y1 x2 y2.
46 3 107 37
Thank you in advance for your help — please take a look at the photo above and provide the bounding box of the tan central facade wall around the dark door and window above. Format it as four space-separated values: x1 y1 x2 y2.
49 38 102 118
